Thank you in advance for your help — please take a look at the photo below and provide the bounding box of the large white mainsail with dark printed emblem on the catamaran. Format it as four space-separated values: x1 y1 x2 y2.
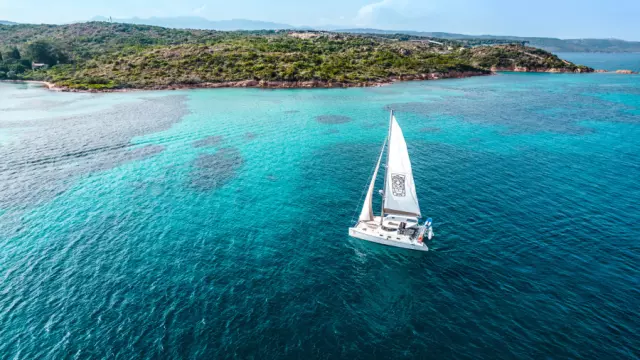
384 116 420 217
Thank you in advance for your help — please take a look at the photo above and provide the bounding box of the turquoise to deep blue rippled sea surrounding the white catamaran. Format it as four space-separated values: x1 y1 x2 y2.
0 66 640 359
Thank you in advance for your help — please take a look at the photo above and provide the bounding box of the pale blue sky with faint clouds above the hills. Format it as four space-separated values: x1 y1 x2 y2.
0 0 640 41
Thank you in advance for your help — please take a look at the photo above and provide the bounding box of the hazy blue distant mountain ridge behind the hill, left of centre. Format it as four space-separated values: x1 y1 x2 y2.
91 16 295 31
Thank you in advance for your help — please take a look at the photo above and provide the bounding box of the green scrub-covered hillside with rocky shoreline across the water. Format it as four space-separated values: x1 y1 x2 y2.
0 22 592 90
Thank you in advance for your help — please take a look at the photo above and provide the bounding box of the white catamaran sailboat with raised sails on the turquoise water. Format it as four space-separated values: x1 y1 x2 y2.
349 110 433 251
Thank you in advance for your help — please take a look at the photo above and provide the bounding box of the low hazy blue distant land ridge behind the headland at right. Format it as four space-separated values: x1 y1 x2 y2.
335 28 640 53
